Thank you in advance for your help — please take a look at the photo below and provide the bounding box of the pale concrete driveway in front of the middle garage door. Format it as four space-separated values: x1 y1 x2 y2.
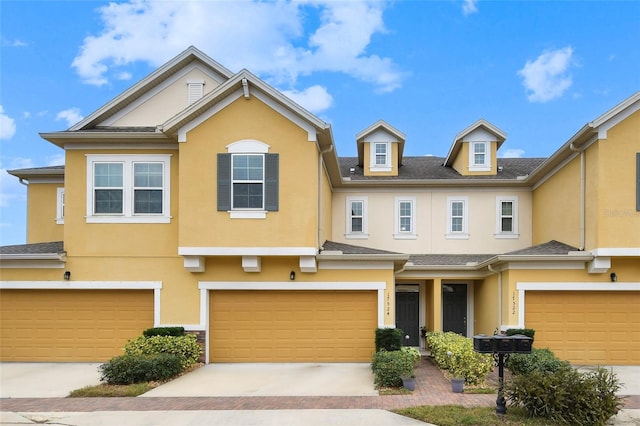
142 363 378 397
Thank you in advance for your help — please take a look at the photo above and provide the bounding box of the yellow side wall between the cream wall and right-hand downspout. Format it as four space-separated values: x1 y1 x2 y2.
532 156 580 247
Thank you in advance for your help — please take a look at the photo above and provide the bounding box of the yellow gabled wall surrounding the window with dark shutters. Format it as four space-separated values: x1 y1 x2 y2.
179 98 319 247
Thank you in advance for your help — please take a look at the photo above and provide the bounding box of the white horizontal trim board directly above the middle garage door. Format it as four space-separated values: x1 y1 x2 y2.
198 281 387 290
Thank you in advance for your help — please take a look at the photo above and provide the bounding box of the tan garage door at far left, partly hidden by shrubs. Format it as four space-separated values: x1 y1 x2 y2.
0 290 153 362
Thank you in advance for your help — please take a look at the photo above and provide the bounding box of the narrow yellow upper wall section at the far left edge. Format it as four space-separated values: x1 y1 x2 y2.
27 182 64 243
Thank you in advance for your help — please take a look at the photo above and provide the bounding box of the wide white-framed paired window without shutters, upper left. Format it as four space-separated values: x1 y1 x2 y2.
87 154 171 223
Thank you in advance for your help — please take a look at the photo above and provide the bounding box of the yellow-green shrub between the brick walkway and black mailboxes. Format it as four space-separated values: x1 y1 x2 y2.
427 332 493 385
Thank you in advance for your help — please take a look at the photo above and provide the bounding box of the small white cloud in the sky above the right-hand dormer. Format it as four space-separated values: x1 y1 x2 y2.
518 46 573 102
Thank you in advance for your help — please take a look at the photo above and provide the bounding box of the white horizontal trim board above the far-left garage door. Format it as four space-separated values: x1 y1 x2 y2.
0 281 162 290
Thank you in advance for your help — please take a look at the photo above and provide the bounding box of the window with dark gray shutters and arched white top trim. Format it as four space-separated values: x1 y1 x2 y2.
217 139 279 219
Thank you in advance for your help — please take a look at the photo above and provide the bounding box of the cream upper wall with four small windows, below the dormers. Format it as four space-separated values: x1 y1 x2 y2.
333 188 531 254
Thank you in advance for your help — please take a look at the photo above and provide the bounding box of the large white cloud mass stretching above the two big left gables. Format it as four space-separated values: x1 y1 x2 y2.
72 0 406 92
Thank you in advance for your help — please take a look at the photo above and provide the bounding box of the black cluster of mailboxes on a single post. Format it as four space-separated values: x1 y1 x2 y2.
473 334 533 414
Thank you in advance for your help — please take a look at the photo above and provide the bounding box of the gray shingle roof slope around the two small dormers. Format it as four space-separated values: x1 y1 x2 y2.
338 157 545 181
